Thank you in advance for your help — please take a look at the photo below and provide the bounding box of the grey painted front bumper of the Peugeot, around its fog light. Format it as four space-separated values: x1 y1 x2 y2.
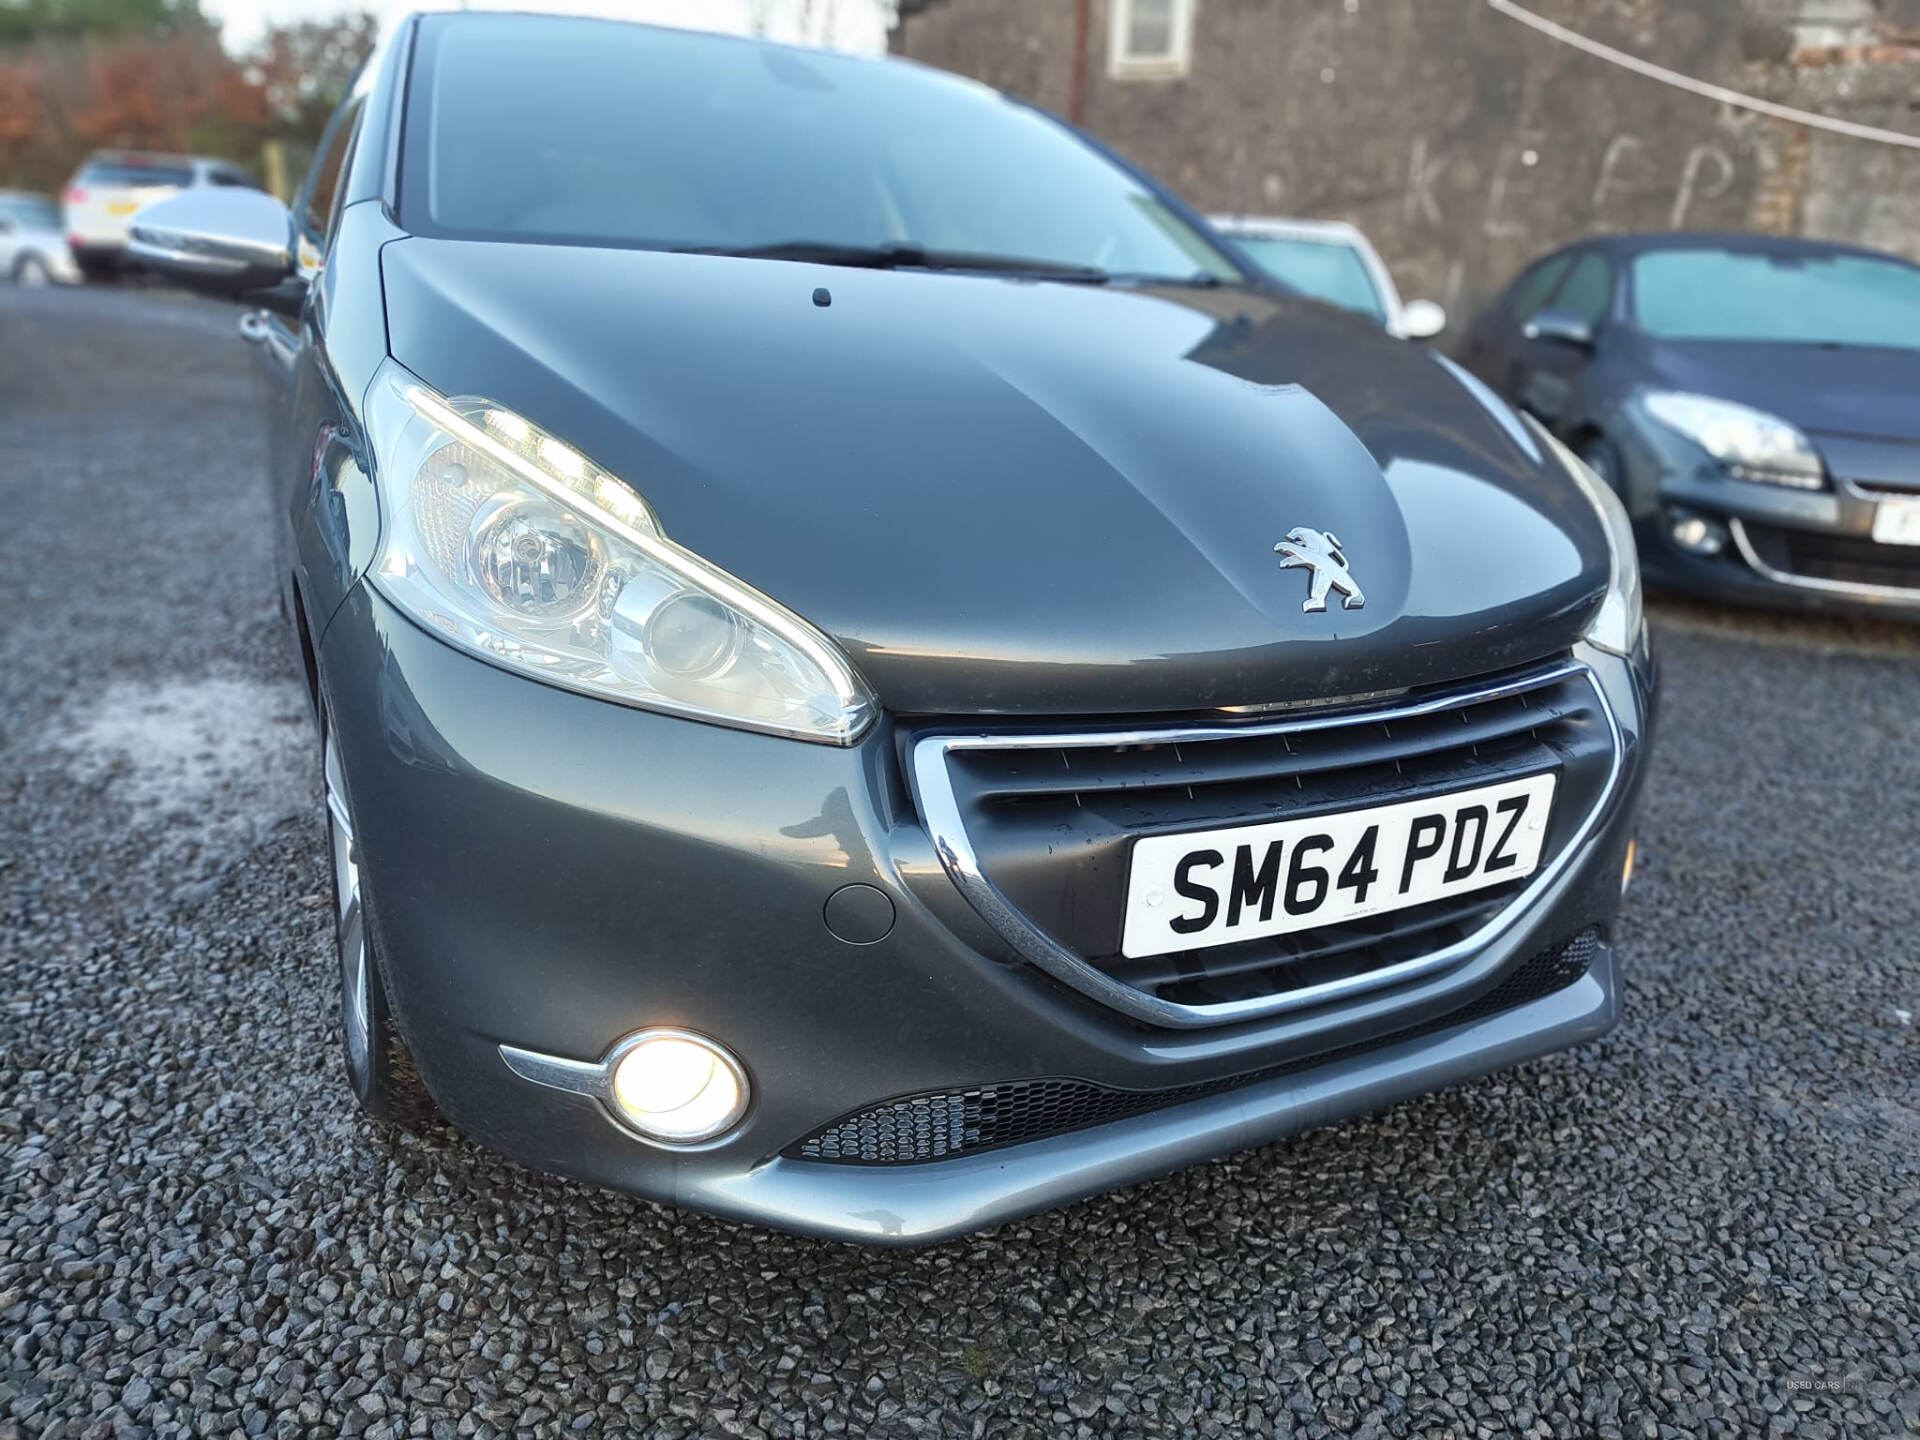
321 586 1651 1242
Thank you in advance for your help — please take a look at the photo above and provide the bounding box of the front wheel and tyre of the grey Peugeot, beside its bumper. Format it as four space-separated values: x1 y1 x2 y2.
321 716 440 1129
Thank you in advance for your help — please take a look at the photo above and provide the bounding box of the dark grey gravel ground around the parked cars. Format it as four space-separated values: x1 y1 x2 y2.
0 292 1920 1440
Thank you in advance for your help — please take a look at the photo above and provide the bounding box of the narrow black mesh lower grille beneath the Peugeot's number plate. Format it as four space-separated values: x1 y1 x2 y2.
787 929 1599 1165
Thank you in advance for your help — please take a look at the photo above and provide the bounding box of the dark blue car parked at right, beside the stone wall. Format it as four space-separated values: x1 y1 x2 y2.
1461 234 1920 614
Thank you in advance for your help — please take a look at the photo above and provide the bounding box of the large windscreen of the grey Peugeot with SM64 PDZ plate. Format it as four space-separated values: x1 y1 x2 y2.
401 15 1240 282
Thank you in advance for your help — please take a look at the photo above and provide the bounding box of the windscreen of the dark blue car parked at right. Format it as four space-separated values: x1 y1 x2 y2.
1632 250 1920 349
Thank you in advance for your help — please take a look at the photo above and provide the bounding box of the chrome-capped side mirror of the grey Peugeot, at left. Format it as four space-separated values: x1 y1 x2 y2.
127 184 301 309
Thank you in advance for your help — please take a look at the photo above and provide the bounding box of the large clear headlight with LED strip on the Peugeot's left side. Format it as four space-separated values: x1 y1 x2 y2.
367 361 874 745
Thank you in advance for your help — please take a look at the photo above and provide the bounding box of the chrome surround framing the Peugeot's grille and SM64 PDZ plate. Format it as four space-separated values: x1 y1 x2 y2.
908 659 1624 1029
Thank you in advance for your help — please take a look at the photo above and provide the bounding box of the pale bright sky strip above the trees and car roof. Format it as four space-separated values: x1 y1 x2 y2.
200 0 891 54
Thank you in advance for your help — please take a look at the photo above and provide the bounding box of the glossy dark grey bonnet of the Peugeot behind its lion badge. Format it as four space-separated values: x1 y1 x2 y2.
382 238 1607 714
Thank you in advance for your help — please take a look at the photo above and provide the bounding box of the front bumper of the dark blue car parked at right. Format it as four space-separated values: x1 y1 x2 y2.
1615 416 1920 616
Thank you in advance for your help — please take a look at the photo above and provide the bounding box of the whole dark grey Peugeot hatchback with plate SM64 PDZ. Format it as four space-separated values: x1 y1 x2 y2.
123 13 1653 1242
